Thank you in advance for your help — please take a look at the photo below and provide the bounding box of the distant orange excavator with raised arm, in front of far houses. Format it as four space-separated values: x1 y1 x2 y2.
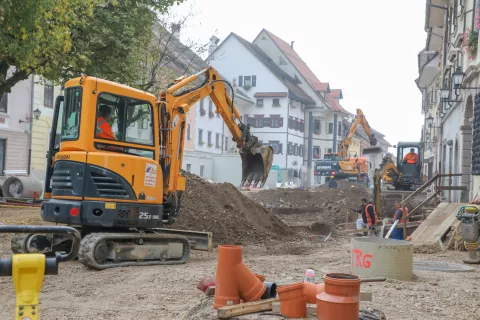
316 109 382 184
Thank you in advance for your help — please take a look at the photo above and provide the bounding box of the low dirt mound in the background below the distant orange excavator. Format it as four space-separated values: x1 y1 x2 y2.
249 184 371 226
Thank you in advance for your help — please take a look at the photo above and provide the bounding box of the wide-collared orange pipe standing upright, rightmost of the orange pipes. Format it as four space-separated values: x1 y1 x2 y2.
317 273 361 320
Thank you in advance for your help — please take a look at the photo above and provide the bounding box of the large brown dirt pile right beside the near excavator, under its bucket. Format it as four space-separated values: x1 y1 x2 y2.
171 173 293 244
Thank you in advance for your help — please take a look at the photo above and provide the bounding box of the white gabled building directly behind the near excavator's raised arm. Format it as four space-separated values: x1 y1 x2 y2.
208 33 315 180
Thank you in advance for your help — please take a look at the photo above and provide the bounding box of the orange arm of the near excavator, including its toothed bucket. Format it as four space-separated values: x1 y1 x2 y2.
160 67 273 191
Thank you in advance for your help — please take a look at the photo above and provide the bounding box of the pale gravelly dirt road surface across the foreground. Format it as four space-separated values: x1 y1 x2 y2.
0 209 480 320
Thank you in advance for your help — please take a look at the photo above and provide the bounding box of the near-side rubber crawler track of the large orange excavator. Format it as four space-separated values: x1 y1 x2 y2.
78 232 190 270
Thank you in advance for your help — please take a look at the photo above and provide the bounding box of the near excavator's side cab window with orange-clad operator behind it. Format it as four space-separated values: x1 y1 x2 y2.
95 92 154 159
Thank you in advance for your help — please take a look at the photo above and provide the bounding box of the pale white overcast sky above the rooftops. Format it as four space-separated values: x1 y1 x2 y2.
168 0 426 148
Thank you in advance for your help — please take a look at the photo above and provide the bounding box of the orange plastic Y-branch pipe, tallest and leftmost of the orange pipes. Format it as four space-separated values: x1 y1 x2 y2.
213 245 266 309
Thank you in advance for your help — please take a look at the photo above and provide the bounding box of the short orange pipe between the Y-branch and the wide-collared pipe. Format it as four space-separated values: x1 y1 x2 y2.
277 283 307 318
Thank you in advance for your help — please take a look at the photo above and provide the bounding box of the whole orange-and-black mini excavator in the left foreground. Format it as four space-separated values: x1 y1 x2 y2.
8 68 273 270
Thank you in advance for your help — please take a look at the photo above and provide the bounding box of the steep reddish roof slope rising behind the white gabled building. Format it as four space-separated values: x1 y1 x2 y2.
263 29 330 92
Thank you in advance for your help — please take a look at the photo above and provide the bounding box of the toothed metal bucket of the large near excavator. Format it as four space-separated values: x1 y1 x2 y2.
240 143 273 188
